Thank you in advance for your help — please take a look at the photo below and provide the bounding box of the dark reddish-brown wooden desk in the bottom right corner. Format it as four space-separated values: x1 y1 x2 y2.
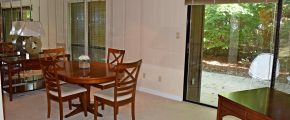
217 88 290 120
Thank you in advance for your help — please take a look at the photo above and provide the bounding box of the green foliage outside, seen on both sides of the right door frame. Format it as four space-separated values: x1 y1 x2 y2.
203 0 290 74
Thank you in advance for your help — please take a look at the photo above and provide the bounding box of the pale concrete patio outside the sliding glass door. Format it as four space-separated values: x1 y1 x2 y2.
200 71 290 106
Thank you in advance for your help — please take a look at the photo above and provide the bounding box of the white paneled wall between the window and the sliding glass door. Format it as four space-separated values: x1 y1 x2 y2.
113 0 187 100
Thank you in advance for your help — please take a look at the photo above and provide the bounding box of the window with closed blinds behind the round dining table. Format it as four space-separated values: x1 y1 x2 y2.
69 0 106 62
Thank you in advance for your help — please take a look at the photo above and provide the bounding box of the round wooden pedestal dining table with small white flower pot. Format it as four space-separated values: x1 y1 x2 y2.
57 61 116 117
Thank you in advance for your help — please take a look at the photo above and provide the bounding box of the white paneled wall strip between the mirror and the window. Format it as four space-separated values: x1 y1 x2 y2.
40 0 68 49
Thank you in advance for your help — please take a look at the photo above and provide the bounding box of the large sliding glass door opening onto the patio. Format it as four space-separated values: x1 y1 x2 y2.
185 3 276 106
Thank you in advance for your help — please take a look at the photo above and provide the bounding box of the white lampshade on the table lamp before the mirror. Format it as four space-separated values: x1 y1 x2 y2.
10 21 44 37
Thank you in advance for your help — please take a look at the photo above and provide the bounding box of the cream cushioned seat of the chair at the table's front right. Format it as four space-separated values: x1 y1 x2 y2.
94 88 132 102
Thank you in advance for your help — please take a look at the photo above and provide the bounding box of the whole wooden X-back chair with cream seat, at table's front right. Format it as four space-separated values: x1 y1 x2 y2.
94 60 142 120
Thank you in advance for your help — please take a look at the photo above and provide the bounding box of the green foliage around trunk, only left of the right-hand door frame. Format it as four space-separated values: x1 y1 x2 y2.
204 3 276 61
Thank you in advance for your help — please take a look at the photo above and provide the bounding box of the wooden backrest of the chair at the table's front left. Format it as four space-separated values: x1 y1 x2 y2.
39 57 61 96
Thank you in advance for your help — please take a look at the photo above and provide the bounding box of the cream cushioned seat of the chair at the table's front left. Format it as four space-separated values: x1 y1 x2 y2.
49 83 87 97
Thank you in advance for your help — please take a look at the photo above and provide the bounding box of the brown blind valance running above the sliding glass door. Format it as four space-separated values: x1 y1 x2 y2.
185 0 278 5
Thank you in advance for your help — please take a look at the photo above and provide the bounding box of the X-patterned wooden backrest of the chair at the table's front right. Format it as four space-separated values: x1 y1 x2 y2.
114 60 142 101
